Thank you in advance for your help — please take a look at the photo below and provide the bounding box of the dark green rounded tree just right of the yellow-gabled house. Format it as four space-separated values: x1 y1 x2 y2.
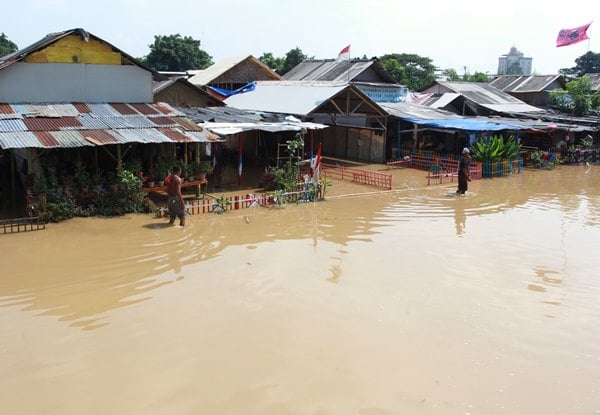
141 34 213 72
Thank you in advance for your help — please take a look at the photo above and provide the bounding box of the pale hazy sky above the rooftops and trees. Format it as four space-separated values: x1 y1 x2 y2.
0 0 600 75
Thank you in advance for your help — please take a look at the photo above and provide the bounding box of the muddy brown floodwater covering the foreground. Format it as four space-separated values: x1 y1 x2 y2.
0 166 600 415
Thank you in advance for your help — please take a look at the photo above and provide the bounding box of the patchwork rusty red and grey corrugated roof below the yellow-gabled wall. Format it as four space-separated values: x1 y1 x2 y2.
0 103 222 149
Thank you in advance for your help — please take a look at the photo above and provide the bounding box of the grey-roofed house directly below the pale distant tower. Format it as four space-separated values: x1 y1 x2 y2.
489 75 566 107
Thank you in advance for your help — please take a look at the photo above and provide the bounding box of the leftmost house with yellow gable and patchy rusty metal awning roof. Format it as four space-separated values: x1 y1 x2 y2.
0 28 220 214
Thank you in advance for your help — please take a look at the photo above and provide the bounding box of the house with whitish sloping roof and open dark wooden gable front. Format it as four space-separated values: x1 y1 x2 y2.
225 81 387 162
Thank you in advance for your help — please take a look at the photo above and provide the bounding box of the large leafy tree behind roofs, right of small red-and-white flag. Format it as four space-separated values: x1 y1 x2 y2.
379 53 436 90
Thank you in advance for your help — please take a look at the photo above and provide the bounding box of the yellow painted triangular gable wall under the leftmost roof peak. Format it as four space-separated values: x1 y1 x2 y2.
25 35 121 65
